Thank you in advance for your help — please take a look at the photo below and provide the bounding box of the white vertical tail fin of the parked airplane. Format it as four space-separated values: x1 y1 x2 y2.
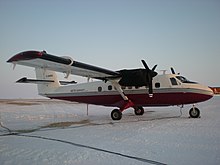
35 68 60 96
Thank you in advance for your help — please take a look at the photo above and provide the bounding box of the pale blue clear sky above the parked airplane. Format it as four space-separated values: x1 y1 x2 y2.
0 0 220 99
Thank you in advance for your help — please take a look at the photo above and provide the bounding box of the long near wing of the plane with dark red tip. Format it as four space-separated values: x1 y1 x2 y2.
7 51 121 81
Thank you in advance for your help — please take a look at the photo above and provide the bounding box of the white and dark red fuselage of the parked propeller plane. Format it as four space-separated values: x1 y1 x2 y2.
43 74 213 106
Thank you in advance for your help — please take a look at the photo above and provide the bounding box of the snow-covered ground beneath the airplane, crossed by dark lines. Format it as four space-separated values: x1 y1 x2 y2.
0 97 220 165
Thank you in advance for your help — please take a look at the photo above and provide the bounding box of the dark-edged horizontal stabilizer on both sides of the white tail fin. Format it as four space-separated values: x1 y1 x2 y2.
16 77 77 85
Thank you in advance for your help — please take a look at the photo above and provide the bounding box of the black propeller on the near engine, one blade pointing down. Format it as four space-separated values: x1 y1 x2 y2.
141 60 157 97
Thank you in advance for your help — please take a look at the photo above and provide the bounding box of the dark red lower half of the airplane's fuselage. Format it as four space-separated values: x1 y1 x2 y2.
48 93 212 108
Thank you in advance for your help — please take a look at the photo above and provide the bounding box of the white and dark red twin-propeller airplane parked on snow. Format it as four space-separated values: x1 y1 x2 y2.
7 51 213 120
